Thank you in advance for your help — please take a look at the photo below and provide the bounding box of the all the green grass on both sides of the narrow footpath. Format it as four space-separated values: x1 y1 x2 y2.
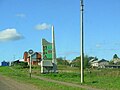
0 66 120 90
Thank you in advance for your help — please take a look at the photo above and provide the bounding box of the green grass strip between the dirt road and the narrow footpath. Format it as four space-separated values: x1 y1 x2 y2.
0 67 84 90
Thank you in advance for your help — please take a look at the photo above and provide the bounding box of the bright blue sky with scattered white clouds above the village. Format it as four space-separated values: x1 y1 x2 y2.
0 0 120 61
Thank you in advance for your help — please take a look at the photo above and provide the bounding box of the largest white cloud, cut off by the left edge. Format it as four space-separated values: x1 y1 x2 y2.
0 28 22 42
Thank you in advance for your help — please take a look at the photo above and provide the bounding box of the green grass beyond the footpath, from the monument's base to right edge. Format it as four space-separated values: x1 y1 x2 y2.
32 67 120 90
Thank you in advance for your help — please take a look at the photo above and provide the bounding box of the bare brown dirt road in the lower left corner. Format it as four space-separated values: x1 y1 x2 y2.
0 75 38 90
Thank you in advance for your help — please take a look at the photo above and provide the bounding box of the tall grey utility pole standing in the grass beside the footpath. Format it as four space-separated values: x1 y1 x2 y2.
81 0 84 83
